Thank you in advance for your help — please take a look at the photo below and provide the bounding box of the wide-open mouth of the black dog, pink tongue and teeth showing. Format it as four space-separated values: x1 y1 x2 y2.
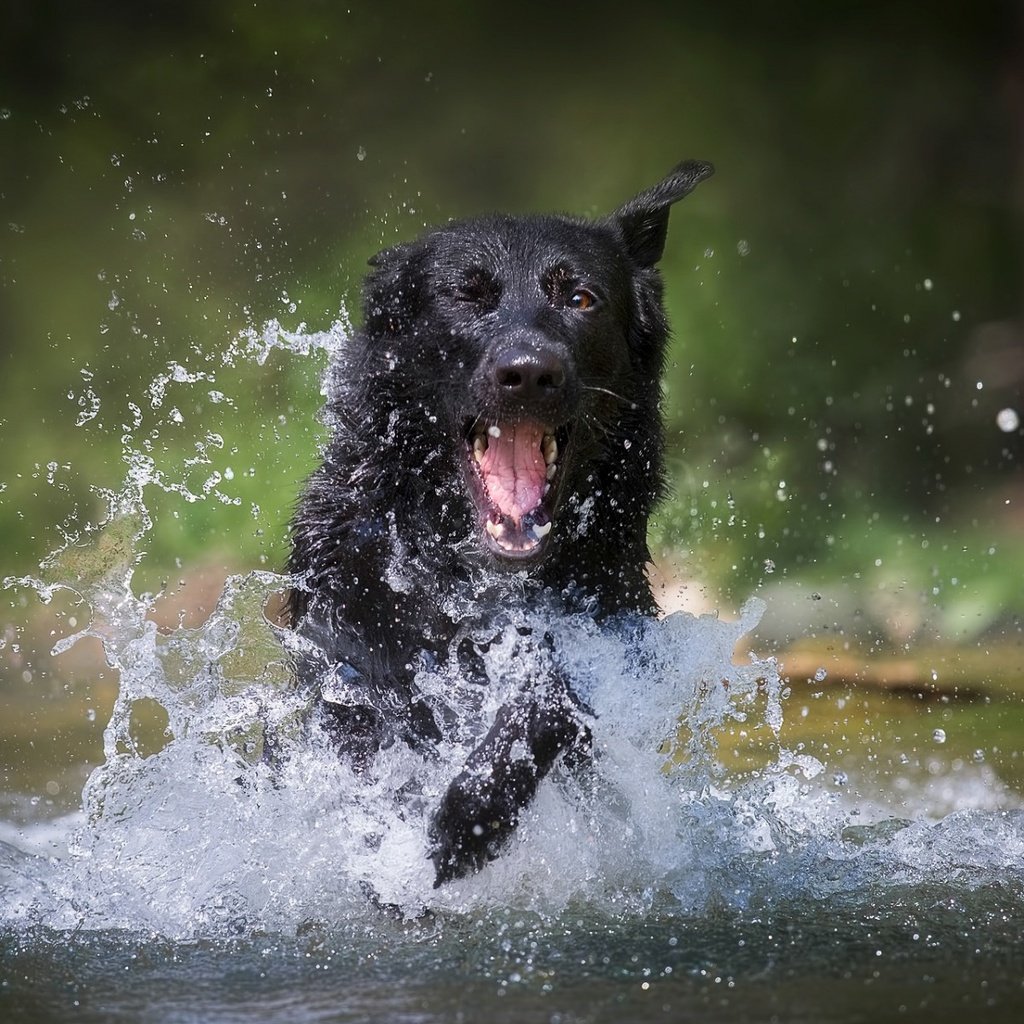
466 420 567 561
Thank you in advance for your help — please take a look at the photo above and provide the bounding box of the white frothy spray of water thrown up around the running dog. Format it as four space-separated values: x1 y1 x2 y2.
0 323 1024 937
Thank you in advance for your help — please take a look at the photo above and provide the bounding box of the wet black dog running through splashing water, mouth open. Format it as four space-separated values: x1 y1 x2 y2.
289 162 712 885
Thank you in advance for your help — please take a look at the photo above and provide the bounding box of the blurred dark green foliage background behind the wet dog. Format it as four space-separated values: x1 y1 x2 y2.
0 0 1024 635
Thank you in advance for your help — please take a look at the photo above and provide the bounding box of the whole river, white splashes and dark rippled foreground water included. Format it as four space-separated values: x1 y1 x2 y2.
0 323 1024 1022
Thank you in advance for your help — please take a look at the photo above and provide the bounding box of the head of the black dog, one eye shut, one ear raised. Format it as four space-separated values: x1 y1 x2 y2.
359 162 712 567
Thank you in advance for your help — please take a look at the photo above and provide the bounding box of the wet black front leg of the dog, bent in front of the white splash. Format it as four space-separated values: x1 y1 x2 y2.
431 693 591 888
